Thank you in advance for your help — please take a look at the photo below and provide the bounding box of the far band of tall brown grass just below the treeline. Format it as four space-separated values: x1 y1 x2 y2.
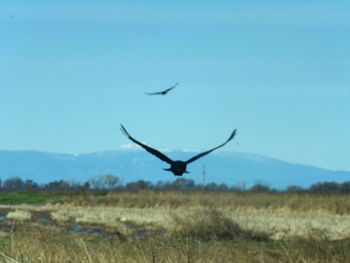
60 190 350 214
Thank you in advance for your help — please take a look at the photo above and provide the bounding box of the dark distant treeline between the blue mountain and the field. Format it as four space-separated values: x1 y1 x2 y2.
0 174 350 193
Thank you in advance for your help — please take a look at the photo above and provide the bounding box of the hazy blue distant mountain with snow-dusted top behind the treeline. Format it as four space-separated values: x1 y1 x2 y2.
0 150 350 189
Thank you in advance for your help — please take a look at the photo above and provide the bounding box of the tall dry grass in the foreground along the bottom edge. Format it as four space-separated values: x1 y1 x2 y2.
0 221 350 263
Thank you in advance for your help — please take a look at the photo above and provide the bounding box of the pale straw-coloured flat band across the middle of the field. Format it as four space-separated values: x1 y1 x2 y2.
0 205 350 240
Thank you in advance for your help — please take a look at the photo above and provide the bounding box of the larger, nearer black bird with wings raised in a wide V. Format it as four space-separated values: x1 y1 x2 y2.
120 124 237 176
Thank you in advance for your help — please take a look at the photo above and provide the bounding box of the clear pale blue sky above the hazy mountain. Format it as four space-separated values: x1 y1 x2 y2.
0 0 350 171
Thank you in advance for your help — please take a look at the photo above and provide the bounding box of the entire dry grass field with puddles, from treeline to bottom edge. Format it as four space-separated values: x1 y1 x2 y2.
0 191 350 263
